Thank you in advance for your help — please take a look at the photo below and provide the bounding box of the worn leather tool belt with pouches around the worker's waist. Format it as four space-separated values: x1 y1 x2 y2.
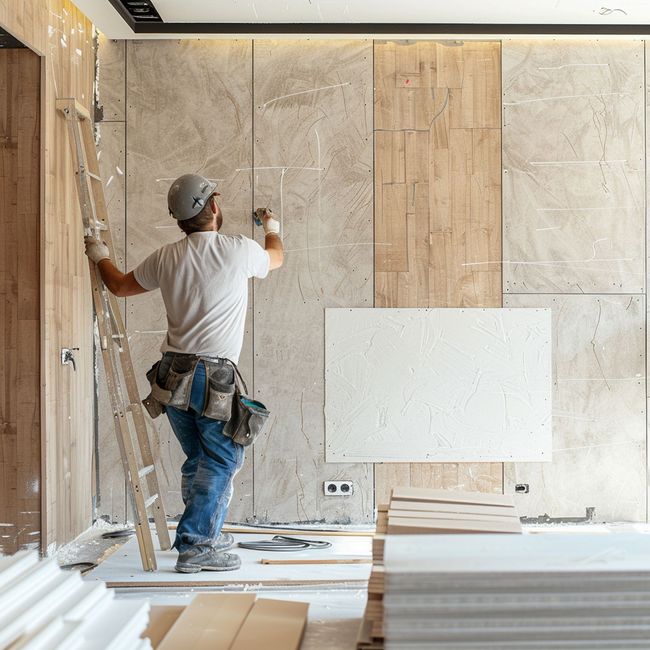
142 352 270 446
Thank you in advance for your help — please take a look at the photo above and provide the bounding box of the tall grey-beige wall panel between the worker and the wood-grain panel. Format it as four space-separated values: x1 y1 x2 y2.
254 40 374 523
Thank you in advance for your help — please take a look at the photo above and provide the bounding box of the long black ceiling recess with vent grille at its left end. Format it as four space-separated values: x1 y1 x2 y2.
109 0 650 36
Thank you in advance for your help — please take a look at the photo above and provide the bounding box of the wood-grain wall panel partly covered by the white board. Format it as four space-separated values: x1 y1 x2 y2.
374 41 503 503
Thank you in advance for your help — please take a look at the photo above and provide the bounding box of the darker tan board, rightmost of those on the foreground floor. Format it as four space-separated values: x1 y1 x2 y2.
231 598 309 650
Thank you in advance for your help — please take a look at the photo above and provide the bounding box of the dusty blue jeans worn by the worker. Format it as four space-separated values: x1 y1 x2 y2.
166 362 244 553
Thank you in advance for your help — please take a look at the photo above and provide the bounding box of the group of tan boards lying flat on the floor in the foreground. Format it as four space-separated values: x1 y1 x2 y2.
146 593 309 650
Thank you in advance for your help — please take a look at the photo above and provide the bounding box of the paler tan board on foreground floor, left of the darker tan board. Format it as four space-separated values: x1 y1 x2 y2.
158 594 256 650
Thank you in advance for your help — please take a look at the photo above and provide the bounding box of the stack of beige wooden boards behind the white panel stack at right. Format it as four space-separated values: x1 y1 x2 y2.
357 487 522 650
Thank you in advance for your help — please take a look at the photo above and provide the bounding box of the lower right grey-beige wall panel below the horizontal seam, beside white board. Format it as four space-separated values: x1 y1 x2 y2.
505 295 646 521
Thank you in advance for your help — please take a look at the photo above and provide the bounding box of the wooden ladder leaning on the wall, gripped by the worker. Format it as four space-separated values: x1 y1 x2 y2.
56 99 171 571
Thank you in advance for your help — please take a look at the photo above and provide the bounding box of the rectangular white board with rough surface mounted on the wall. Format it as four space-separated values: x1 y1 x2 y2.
325 309 552 462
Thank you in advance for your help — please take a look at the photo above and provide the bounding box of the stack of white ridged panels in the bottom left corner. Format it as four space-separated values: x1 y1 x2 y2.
0 551 151 650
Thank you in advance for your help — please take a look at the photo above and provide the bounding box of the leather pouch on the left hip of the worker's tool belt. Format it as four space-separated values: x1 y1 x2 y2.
142 354 199 418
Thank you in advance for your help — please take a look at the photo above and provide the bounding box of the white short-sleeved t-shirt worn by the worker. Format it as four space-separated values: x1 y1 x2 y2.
133 232 270 363
